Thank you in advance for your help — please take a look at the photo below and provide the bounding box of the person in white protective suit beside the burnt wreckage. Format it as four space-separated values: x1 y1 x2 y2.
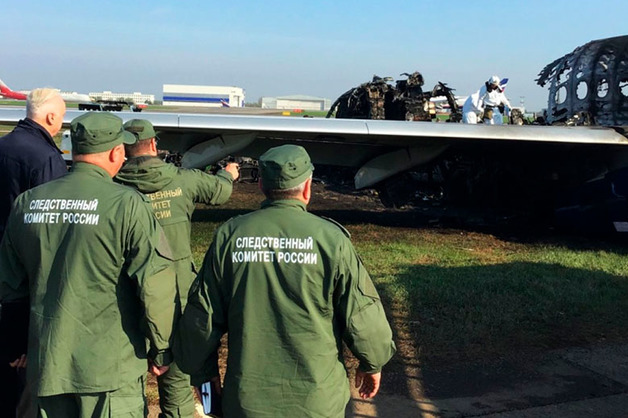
462 75 512 125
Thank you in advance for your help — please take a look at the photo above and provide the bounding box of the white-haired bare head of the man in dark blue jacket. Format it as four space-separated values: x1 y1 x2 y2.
26 88 65 136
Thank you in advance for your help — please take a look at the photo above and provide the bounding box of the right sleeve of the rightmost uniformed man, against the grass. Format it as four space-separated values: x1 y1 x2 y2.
335 238 396 373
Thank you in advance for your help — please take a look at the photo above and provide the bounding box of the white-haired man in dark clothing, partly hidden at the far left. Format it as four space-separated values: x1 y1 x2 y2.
0 88 67 417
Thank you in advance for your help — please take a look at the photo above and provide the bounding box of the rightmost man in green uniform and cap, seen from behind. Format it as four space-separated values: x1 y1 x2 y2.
174 145 395 417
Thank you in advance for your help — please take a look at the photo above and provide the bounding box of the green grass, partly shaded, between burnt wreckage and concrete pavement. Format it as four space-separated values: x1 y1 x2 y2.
193 217 628 362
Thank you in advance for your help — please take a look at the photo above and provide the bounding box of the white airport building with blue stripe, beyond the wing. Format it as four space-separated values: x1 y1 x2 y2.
163 84 244 107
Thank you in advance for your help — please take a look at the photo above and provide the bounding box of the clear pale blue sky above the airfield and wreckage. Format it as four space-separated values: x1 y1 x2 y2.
0 0 628 111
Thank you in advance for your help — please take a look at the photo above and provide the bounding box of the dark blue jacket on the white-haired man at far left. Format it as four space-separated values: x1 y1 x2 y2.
0 119 67 240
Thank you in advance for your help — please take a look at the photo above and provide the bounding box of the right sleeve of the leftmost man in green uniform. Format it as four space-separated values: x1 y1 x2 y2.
125 199 176 366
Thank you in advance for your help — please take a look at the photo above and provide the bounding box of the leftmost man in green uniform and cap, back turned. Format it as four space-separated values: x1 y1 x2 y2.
0 112 175 418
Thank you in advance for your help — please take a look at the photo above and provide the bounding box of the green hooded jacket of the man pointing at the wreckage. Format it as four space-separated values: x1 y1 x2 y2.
115 157 233 308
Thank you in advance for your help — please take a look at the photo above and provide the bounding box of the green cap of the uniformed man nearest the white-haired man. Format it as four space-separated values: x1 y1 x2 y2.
70 112 135 154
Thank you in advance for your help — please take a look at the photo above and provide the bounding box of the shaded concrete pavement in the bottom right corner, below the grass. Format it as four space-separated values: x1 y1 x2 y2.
346 344 628 418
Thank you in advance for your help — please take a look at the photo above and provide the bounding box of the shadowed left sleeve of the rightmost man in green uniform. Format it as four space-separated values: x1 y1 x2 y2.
174 233 229 385
